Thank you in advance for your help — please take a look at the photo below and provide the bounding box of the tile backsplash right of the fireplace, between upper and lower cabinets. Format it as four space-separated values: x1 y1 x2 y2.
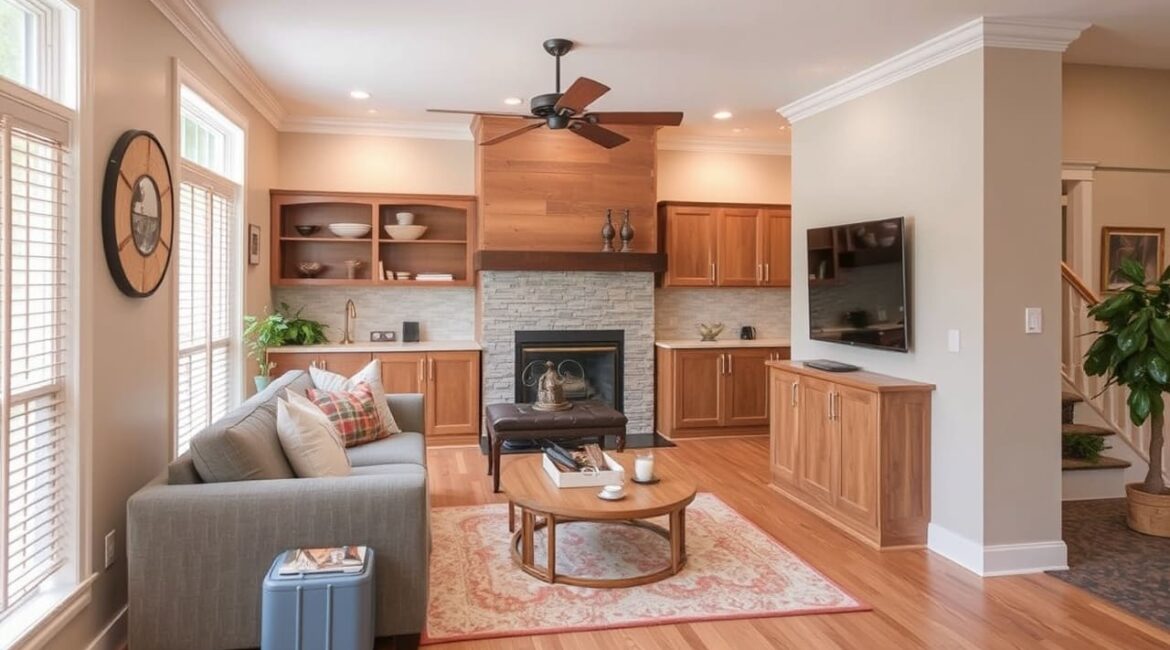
654 288 792 339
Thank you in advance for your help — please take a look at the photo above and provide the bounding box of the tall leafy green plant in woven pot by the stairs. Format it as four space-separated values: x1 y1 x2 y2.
1085 260 1170 537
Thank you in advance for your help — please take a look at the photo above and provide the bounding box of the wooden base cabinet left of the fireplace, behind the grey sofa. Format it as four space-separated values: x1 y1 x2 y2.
268 350 480 444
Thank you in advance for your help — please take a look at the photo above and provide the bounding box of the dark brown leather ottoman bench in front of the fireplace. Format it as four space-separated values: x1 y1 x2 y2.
484 401 626 492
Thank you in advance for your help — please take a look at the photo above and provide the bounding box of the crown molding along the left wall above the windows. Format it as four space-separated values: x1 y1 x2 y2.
150 0 285 129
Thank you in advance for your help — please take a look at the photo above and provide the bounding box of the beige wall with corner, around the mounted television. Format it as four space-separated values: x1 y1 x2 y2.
792 50 1064 571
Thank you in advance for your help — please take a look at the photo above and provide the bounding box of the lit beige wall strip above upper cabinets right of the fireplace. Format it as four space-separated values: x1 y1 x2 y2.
658 150 792 203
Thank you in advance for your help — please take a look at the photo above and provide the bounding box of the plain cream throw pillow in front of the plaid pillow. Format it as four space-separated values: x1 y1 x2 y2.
276 390 350 478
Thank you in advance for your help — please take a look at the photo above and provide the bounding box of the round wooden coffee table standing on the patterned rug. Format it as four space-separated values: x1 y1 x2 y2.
500 451 697 588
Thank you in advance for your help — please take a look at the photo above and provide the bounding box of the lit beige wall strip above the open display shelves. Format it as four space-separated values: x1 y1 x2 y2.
278 133 475 194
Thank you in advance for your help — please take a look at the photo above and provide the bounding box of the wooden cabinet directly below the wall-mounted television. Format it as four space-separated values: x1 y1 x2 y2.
768 361 934 548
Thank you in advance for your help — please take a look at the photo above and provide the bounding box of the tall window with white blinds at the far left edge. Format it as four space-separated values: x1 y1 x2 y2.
0 0 84 646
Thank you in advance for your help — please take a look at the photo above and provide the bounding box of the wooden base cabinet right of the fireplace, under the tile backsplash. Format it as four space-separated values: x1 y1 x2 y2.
655 347 789 437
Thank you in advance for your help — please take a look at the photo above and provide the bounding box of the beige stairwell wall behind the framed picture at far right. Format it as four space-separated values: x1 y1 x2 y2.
1064 65 1170 289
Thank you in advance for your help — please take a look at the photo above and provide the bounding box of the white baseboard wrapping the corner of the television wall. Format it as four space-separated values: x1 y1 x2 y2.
927 524 1068 578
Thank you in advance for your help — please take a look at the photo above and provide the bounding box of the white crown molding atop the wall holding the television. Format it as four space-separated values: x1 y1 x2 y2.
776 18 1088 123
